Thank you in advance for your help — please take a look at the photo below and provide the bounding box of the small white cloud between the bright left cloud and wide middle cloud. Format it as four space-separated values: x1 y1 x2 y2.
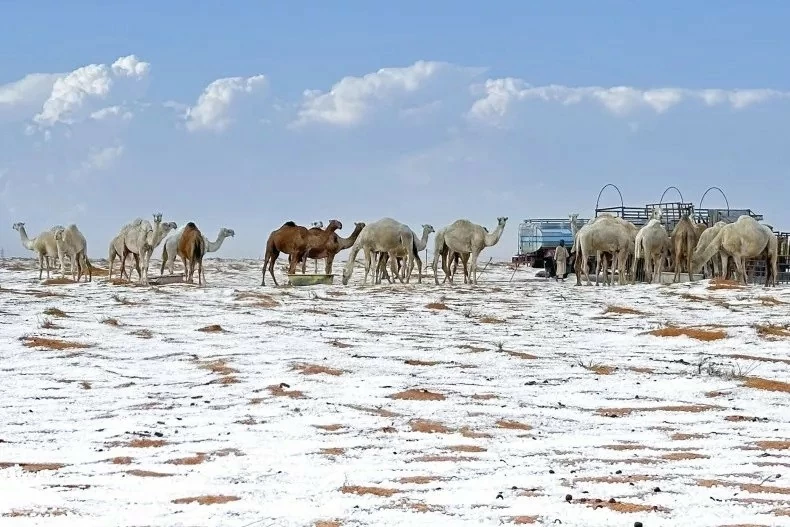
186 75 267 132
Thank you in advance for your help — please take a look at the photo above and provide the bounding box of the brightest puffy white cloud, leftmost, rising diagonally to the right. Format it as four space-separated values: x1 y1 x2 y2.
33 55 149 127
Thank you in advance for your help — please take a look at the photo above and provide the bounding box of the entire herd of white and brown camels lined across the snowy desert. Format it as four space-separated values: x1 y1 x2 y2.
13 208 778 286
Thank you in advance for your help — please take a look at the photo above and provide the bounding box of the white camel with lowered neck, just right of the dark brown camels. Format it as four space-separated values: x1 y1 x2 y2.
343 218 424 285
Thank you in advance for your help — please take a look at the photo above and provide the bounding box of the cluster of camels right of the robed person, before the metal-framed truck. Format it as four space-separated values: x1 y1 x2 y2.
571 208 778 287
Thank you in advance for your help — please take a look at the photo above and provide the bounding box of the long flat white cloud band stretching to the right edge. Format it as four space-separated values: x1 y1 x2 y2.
467 77 790 124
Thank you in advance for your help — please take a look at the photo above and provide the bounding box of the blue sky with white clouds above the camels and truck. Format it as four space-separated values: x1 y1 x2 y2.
0 1 790 257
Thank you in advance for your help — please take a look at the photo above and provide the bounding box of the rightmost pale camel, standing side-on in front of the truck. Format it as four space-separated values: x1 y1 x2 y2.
691 215 778 287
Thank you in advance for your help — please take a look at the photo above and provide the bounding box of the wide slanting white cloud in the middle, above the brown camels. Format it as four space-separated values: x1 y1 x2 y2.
292 60 464 126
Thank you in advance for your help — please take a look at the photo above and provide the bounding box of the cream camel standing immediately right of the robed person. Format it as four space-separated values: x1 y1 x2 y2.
573 214 636 285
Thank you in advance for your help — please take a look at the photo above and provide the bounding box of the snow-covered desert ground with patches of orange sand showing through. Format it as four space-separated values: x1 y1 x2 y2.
0 258 790 527
